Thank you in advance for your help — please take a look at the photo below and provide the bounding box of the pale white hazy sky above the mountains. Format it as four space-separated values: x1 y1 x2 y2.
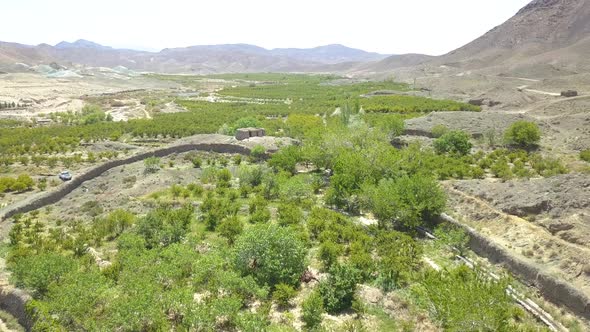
0 0 530 55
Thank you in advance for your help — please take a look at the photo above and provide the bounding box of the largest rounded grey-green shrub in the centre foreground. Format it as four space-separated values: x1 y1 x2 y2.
234 225 307 287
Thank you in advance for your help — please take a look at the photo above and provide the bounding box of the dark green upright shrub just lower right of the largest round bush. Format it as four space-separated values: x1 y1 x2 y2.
319 264 360 314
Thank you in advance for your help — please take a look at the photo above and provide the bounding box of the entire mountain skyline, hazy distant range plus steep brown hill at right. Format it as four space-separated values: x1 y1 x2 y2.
0 0 590 77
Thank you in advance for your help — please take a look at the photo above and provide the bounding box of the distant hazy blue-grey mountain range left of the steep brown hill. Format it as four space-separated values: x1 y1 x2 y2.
0 39 388 73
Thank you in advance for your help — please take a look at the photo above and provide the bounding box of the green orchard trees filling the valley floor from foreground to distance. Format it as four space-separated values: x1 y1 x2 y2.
0 74 566 331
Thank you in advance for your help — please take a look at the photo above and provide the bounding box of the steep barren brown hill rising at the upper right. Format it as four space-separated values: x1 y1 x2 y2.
438 0 590 71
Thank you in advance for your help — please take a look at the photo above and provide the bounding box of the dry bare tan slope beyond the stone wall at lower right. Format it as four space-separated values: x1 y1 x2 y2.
444 179 590 295
